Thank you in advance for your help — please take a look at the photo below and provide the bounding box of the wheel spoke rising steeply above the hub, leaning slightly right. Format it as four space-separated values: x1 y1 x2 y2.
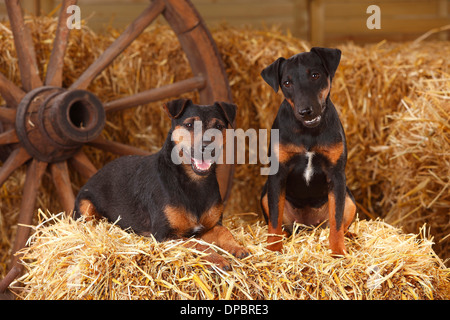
45 0 77 87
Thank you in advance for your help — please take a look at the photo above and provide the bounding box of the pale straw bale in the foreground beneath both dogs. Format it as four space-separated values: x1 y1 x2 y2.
16 211 450 300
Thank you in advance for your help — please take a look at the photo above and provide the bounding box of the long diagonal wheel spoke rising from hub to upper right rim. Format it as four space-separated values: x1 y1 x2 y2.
70 0 165 89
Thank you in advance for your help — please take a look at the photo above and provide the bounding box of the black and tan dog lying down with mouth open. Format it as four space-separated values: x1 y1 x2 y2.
75 99 249 269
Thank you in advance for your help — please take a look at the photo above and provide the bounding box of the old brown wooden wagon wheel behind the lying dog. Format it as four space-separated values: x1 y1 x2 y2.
0 0 233 292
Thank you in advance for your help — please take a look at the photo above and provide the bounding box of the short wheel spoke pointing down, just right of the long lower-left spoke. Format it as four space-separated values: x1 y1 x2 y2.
50 161 75 215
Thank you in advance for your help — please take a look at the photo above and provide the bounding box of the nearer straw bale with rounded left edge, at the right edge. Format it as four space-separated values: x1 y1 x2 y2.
379 74 450 259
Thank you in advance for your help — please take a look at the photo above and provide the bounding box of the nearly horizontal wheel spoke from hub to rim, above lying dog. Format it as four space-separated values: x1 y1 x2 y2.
104 76 206 112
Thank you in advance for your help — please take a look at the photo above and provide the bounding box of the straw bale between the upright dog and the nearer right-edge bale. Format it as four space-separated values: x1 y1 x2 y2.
331 41 450 218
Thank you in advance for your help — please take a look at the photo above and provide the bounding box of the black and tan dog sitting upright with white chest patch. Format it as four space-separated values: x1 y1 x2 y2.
261 47 356 255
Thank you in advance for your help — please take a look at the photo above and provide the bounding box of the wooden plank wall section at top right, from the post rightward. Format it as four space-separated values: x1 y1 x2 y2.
310 0 450 45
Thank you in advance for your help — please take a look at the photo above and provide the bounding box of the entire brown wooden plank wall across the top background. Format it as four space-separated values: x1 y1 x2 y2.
0 0 450 45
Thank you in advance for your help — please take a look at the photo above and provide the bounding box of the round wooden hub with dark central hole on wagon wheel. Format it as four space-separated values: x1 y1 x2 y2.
16 86 105 163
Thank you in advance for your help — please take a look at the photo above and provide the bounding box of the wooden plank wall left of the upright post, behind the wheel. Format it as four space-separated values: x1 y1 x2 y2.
0 0 309 39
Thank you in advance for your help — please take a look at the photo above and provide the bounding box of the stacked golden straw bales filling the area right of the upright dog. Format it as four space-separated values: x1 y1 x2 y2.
332 42 450 259
